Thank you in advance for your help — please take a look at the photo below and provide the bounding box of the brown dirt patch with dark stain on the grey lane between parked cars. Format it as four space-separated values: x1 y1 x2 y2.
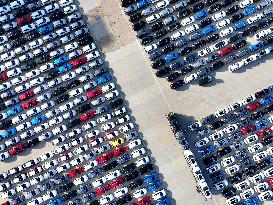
86 0 135 52
